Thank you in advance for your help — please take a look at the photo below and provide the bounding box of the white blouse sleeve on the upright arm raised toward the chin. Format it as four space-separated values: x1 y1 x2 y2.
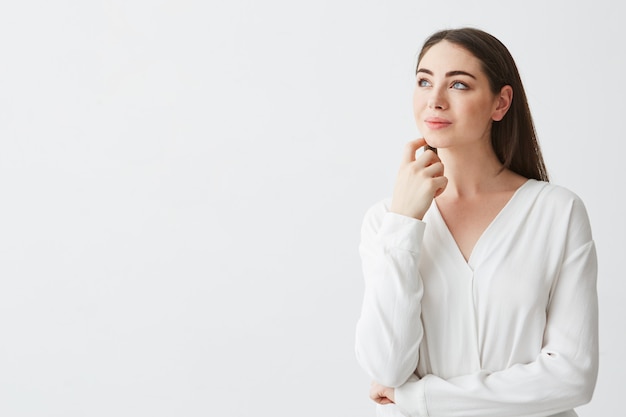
355 202 425 387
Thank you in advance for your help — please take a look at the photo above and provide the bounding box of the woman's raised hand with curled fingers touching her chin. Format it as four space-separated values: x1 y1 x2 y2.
391 138 448 220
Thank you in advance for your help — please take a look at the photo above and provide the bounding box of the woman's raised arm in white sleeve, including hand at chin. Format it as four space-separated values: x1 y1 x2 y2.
356 139 447 387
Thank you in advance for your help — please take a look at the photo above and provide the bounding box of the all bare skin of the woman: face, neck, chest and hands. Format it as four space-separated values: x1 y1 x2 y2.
370 41 527 404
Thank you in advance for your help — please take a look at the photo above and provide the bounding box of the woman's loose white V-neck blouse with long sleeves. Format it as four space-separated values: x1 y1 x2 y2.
356 180 598 417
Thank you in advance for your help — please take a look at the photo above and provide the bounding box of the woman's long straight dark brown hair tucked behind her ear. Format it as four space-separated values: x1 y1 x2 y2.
416 28 549 181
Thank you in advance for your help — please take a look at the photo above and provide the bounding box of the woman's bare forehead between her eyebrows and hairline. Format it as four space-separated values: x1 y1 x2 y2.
418 41 482 76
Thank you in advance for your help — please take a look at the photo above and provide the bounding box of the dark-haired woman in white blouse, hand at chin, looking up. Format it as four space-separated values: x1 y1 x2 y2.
356 28 598 417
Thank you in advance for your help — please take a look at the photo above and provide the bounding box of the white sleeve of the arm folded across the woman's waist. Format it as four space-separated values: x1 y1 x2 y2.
395 193 598 417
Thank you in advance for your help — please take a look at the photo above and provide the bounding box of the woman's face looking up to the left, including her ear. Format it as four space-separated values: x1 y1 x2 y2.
413 41 508 148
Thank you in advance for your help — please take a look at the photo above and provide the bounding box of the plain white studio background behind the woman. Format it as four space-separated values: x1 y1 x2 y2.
0 0 626 417
